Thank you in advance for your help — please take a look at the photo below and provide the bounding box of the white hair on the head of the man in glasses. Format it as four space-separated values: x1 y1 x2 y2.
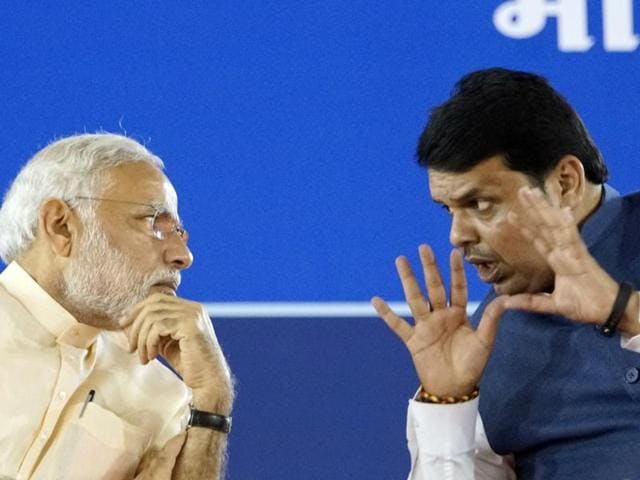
0 133 164 264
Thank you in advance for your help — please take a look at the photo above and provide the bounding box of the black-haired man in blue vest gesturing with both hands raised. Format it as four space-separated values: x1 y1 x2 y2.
372 68 640 480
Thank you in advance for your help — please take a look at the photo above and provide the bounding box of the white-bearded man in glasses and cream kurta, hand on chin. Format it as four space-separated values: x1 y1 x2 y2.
0 134 233 480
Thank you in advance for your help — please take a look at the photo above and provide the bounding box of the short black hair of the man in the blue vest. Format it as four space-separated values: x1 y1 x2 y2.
417 68 608 185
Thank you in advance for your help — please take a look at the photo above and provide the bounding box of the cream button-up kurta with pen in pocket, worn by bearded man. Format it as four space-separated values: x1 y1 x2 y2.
0 262 190 480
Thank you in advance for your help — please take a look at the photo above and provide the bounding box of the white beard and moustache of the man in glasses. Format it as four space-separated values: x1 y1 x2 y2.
62 214 180 330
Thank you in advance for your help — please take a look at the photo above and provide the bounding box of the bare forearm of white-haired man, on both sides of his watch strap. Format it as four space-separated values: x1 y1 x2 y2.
171 385 233 480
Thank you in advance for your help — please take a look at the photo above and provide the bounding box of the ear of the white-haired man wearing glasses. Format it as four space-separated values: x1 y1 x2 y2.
38 198 80 257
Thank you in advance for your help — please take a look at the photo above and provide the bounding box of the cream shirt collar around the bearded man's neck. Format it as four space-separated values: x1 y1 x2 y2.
0 262 101 349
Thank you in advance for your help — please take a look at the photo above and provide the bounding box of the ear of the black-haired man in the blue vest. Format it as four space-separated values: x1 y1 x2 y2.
544 155 586 210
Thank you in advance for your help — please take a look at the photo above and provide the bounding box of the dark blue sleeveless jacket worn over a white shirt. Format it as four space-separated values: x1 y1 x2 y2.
471 187 640 480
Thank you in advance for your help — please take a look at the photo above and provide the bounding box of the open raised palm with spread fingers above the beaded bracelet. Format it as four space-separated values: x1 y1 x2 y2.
371 245 504 397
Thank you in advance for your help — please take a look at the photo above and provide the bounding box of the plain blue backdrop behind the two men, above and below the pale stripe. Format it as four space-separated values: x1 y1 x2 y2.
0 0 640 479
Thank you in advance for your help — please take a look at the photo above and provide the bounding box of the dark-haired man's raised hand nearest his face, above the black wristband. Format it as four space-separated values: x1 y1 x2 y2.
505 188 637 333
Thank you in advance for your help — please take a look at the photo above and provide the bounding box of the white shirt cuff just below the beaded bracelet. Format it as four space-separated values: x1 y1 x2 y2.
407 398 478 457
